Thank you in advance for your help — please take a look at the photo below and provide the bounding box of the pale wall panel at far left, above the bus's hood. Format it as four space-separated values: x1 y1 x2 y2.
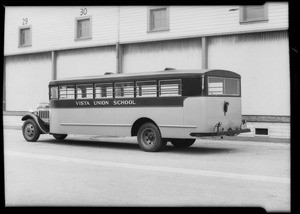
5 53 51 111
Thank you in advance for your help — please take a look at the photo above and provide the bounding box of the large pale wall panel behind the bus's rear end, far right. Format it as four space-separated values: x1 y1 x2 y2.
208 32 290 116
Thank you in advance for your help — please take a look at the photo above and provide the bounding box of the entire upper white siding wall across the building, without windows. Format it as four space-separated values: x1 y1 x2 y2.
4 2 288 55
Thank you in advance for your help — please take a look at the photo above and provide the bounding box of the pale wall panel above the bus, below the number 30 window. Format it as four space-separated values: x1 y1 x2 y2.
56 46 116 79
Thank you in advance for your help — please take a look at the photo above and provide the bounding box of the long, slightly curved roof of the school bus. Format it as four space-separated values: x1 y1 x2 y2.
49 69 240 85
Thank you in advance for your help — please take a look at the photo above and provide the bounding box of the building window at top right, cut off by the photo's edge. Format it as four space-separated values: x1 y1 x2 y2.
240 4 268 23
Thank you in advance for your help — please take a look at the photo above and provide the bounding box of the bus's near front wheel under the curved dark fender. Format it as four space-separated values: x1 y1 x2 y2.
22 119 41 142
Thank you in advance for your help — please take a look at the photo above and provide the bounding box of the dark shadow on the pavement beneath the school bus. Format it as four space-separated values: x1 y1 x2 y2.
38 139 238 154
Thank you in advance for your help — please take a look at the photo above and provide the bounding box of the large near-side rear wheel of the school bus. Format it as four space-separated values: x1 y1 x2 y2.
137 122 167 152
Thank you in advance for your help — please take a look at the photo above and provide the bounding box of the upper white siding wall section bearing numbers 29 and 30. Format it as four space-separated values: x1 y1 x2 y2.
4 6 117 55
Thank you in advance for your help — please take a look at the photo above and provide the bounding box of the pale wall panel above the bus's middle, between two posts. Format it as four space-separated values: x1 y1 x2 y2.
122 39 202 73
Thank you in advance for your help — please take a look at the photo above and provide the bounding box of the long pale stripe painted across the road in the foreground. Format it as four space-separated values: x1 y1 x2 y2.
4 151 290 184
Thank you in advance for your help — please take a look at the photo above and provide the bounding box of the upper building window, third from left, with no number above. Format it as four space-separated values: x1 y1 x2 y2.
148 7 169 32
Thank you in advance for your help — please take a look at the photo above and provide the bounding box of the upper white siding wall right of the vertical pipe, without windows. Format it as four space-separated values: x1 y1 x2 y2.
120 2 288 43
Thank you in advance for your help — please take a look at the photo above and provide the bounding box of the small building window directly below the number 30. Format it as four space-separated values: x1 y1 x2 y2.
75 16 92 40
